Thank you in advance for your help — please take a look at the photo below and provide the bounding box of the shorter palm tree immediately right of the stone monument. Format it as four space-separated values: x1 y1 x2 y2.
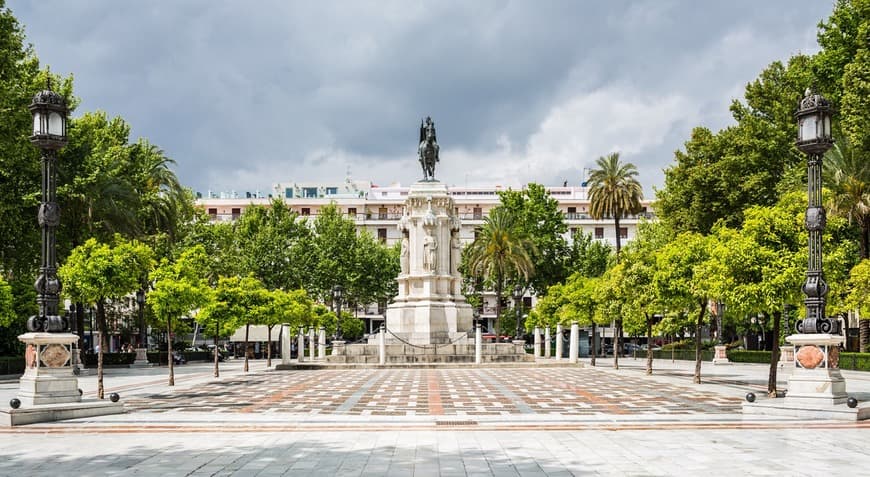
464 207 534 342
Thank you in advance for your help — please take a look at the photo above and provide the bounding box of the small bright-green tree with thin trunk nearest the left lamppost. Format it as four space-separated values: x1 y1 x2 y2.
57 237 154 399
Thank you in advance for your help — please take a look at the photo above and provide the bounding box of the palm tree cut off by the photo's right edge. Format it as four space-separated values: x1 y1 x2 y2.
822 141 870 353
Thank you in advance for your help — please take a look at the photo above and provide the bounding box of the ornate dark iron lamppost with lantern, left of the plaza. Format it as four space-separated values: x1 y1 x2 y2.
27 79 69 332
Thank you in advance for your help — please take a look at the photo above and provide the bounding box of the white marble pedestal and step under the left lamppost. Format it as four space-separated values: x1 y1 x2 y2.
0 333 124 427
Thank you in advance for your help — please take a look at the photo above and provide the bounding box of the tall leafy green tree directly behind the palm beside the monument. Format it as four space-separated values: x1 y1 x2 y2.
498 183 570 296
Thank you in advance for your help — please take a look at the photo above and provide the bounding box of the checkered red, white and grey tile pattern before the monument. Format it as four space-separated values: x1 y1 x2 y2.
126 368 741 417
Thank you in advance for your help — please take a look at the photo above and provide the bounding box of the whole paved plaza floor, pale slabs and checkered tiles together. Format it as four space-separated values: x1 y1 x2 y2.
0 358 870 476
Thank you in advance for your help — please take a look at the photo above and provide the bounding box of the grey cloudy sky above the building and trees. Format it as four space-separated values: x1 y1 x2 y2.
7 0 833 198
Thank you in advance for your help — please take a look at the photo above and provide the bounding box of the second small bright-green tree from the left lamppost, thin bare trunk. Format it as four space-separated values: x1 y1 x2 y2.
147 246 210 386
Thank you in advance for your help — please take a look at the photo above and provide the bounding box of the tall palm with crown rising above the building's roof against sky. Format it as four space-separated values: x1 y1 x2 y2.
589 152 643 260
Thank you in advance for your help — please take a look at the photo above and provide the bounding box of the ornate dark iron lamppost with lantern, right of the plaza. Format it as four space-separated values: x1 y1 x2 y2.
795 88 839 333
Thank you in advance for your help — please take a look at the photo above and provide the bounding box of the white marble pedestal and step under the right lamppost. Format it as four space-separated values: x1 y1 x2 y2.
743 333 870 421
